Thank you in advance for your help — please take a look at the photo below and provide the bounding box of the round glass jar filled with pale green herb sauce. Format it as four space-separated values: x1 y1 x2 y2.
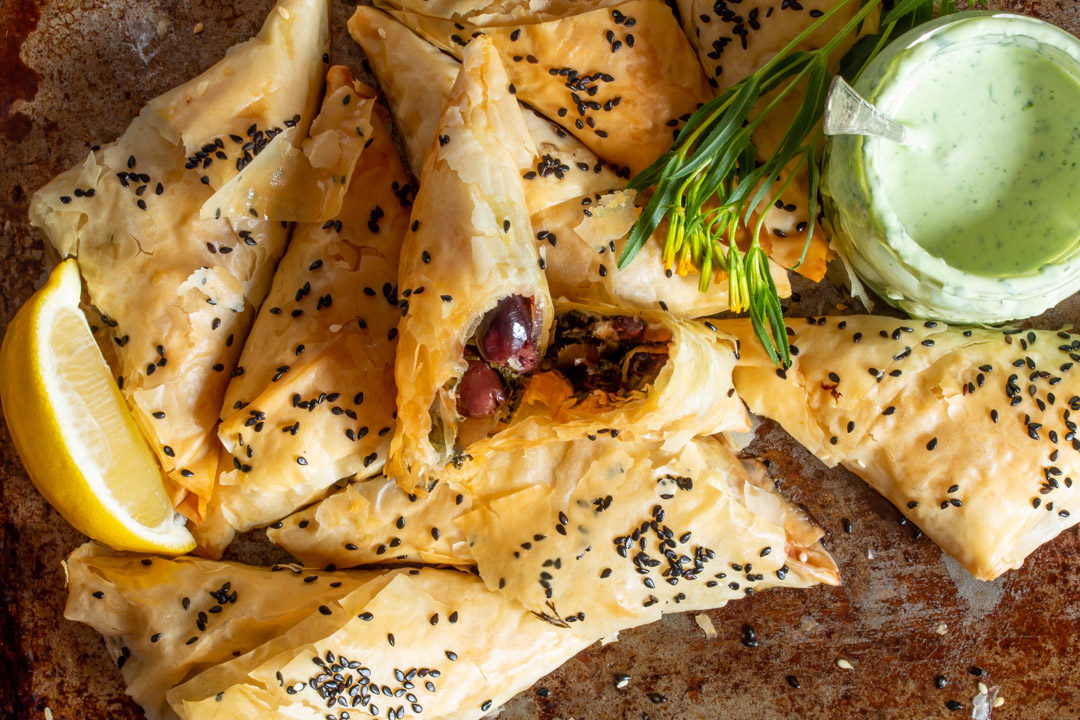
822 12 1080 324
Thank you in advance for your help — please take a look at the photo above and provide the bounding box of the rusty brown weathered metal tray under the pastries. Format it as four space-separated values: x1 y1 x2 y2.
0 0 1080 720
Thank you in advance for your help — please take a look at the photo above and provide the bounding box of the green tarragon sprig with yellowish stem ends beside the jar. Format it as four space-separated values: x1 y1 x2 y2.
619 0 972 367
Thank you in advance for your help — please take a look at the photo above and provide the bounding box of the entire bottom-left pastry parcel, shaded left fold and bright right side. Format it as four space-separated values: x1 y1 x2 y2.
66 544 597 720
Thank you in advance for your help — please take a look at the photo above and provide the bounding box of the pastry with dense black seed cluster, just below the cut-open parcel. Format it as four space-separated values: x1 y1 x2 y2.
457 436 839 635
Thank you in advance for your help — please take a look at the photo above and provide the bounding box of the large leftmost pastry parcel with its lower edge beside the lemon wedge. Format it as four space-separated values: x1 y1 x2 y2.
30 0 329 520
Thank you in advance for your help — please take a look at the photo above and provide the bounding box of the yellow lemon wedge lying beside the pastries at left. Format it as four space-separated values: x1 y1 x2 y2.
0 260 195 554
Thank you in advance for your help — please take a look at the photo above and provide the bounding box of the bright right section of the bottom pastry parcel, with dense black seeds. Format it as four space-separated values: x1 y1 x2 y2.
168 568 596 720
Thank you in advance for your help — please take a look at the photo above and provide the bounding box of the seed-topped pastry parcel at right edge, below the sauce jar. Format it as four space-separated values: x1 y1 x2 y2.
717 315 1080 580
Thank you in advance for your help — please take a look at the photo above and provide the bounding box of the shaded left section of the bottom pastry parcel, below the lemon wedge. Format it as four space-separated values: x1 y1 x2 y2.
64 543 379 720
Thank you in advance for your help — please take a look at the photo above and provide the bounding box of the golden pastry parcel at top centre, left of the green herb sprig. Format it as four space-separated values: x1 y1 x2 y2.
377 0 710 177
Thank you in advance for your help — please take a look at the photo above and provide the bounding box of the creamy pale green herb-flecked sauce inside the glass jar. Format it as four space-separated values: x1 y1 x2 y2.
867 38 1080 277
